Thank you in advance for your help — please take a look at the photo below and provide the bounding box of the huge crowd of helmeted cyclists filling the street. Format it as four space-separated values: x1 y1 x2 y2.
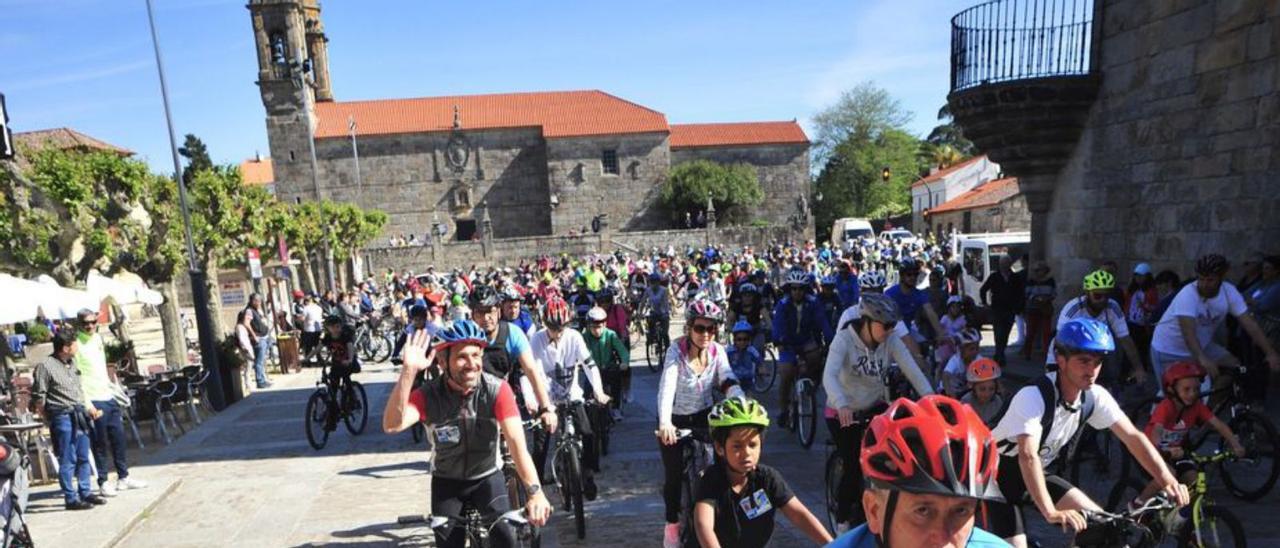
282 239 1280 547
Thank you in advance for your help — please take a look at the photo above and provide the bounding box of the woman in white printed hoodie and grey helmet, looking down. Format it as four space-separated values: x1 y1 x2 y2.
822 293 933 535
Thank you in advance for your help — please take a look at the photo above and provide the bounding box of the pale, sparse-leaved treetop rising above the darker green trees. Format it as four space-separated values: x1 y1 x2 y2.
812 82 914 166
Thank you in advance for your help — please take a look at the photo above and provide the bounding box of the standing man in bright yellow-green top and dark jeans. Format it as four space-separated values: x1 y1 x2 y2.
74 309 147 497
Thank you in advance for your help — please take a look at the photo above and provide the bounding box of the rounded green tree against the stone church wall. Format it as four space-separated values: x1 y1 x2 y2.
659 160 764 224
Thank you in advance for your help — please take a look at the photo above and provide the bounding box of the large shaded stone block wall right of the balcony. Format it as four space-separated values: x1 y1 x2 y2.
1047 0 1280 280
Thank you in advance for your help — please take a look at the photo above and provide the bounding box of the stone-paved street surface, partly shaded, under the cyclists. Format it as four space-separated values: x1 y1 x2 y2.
22 318 1280 548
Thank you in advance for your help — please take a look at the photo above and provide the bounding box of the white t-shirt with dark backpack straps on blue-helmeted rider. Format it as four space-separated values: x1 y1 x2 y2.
991 373 1124 466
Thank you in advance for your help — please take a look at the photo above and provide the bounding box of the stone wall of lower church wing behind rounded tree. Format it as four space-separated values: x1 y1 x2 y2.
671 145 812 224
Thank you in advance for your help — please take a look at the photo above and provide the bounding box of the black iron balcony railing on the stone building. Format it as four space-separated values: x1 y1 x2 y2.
951 0 1094 91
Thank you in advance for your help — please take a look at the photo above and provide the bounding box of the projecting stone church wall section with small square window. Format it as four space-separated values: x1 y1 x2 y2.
544 133 671 234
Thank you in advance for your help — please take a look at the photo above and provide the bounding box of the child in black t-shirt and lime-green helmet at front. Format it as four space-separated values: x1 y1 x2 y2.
694 397 831 548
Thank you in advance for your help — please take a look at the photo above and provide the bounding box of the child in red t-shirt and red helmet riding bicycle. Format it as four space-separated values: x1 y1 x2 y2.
1138 361 1244 502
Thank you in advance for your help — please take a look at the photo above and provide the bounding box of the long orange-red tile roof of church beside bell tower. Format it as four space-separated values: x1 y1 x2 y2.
316 90 668 138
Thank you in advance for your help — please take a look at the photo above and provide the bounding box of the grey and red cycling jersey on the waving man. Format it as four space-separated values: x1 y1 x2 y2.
408 374 520 480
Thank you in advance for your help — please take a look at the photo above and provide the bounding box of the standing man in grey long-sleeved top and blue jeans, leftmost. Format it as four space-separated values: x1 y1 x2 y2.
31 330 106 510
